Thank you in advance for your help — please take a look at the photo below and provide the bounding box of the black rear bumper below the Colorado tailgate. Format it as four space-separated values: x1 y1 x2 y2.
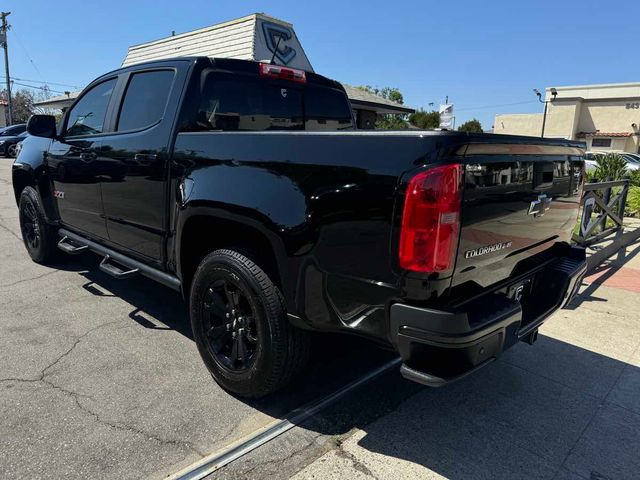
389 248 587 387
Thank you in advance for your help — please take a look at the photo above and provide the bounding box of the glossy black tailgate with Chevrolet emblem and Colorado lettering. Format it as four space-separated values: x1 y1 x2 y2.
452 144 584 288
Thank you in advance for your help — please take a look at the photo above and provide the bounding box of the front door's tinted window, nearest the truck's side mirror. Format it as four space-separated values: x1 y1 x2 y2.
67 78 116 136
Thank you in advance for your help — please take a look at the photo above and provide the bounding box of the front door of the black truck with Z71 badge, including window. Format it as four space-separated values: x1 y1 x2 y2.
47 78 117 238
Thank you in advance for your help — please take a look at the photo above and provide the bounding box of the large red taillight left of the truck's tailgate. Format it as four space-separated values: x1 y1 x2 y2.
399 164 463 273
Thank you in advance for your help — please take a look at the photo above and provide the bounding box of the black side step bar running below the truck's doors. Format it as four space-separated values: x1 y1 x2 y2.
58 228 180 291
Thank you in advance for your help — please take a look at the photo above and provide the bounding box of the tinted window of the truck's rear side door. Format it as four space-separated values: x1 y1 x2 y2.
117 70 174 131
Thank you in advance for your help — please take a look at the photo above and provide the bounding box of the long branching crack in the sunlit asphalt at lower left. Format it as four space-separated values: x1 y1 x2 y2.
0 320 206 457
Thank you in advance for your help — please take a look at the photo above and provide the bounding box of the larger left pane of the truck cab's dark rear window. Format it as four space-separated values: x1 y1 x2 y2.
196 75 304 131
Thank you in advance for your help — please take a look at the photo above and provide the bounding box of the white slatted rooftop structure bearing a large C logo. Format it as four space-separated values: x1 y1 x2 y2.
122 13 313 71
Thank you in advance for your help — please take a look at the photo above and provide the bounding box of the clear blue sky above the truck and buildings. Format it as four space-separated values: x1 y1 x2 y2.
0 0 640 129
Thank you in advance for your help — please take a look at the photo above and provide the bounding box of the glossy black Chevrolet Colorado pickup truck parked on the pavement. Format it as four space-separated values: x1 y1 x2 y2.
13 58 586 397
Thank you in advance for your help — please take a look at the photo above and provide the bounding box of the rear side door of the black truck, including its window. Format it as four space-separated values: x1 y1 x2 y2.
99 67 186 263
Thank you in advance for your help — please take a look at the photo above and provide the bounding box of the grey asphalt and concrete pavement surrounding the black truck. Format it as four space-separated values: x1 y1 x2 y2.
0 159 640 480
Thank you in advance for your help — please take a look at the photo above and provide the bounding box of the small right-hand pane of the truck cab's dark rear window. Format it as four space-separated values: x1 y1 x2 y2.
304 88 353 130
